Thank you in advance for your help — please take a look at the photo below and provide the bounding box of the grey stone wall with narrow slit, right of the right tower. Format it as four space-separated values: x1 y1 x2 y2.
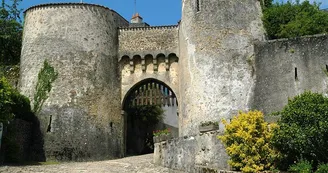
252 35 328 113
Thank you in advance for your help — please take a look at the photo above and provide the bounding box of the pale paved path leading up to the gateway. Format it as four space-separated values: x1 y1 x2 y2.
0 154 182 173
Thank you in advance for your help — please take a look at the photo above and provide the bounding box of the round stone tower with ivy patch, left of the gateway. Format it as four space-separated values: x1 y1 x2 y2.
20 3 128 161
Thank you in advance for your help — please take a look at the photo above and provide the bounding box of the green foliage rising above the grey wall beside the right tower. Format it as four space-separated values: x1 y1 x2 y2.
263 1 328 39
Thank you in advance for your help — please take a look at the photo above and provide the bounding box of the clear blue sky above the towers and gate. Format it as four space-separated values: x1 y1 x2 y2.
21 0 328 25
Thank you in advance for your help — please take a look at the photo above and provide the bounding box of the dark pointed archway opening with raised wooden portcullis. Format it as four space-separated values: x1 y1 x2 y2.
123 79 178 156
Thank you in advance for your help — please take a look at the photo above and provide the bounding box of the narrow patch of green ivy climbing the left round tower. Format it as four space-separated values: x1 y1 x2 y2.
33 60 58 113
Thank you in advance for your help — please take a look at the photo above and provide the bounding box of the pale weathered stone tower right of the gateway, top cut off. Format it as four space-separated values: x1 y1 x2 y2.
179 0 264 135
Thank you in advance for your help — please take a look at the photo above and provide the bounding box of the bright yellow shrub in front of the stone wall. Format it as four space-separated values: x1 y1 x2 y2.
218 111 278 173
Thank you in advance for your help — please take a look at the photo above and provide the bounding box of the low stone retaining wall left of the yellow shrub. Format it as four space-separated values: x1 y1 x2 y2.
154 131 229 172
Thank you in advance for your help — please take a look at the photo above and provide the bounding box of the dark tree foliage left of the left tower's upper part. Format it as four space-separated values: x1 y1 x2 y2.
0 0 22 64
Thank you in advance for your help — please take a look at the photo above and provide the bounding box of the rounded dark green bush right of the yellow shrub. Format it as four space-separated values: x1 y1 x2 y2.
272 92 328 169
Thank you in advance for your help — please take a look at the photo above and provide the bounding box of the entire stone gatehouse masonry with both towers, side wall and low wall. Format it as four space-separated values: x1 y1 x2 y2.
19 0 328 172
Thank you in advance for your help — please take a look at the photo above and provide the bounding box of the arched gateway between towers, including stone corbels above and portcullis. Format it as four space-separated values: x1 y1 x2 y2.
119 50 179 155
